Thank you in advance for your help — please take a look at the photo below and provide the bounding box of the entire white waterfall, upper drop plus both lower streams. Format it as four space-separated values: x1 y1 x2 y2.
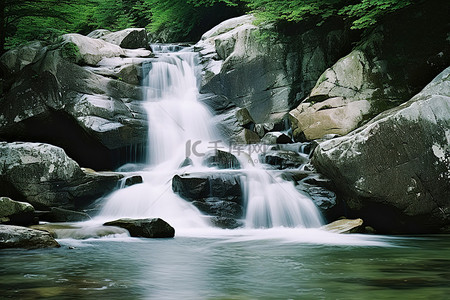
99 45 321 230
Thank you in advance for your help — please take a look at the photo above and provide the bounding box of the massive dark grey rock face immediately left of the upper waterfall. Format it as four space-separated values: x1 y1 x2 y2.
0 34 150 169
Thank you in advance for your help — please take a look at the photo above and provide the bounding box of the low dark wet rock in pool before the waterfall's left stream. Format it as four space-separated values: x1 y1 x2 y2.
103 218 175 238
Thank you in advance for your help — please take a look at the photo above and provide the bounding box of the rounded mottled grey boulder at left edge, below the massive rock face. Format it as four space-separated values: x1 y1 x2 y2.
0 142 122 210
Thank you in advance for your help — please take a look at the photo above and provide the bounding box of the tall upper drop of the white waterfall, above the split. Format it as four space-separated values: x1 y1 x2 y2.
143 52 212 169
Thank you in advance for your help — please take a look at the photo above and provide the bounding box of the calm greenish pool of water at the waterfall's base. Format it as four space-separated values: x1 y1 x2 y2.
0 234 450 299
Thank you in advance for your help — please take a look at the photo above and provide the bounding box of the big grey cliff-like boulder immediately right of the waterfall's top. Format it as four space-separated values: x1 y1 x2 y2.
196 15 350 137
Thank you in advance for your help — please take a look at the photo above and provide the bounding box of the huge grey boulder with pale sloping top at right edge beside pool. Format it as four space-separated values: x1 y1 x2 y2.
313 68 450 233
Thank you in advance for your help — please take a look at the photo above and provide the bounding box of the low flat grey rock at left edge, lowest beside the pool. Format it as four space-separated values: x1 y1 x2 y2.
0 225 60 249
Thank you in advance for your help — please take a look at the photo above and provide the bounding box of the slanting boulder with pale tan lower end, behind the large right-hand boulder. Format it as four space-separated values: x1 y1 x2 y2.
290 1 450 141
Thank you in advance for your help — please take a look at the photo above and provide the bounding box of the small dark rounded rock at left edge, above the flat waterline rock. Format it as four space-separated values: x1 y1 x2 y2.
0 197 34 225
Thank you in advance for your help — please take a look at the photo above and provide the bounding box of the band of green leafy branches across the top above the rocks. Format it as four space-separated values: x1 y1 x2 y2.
0 0 418 53
